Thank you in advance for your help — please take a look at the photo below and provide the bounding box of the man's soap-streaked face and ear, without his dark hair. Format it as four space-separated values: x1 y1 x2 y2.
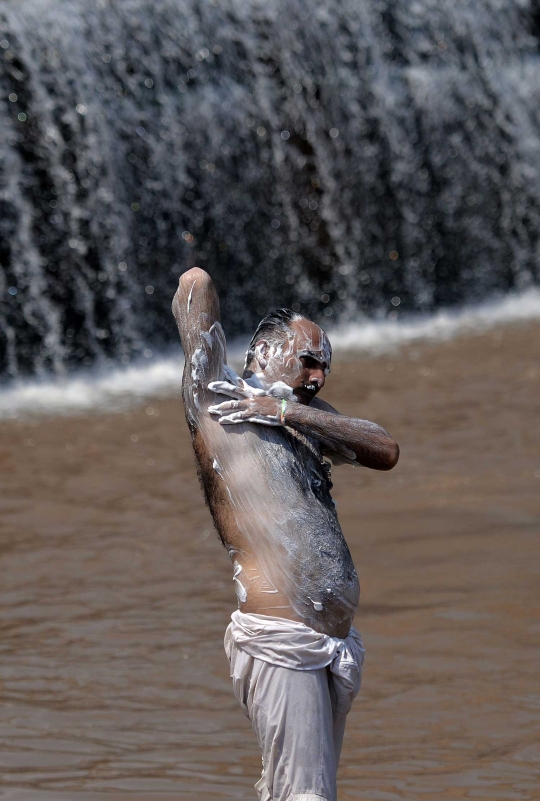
256 320 332 405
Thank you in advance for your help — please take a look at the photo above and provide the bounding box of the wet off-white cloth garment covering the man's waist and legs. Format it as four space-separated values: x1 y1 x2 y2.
221 611 365 801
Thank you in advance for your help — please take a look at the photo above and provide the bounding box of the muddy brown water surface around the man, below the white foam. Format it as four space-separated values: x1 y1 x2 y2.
0 325 540 801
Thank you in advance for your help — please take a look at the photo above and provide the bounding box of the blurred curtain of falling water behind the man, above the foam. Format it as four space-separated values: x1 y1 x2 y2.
0 0 540 377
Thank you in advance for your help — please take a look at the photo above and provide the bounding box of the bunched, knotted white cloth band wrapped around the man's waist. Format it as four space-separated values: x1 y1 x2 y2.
224 610 365 676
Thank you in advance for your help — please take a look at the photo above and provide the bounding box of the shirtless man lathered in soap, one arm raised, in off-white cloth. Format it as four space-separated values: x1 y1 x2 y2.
173 268 399 801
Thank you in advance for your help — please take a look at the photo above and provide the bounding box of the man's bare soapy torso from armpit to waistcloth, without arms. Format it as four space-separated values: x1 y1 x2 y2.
201 420 359 636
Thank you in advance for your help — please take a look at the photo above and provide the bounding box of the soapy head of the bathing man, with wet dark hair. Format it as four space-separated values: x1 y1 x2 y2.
244 309 332 404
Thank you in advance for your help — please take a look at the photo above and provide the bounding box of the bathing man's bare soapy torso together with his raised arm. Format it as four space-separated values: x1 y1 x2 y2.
174 271 359 637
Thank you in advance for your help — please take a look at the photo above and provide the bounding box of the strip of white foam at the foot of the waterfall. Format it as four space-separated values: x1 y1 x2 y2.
0 289 540 420
